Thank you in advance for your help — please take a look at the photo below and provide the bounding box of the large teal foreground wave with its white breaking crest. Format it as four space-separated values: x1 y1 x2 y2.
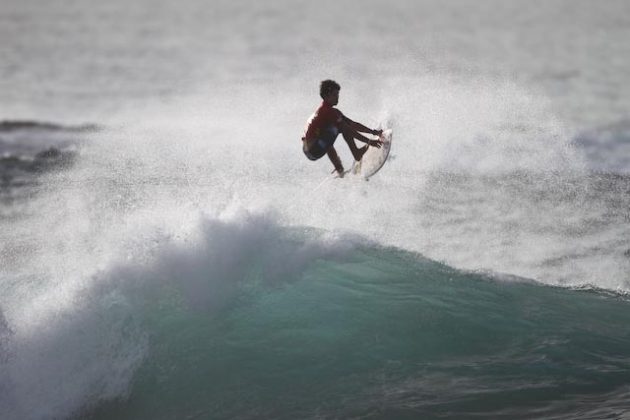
0 208 630 419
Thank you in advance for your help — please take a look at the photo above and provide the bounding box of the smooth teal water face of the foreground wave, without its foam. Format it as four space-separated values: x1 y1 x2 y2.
89 246 630 419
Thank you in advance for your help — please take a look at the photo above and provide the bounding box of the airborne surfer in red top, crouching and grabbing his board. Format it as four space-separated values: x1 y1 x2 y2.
302 80 383 177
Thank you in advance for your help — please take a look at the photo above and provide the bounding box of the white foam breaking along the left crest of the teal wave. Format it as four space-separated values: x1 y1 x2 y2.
0 199 366 418
